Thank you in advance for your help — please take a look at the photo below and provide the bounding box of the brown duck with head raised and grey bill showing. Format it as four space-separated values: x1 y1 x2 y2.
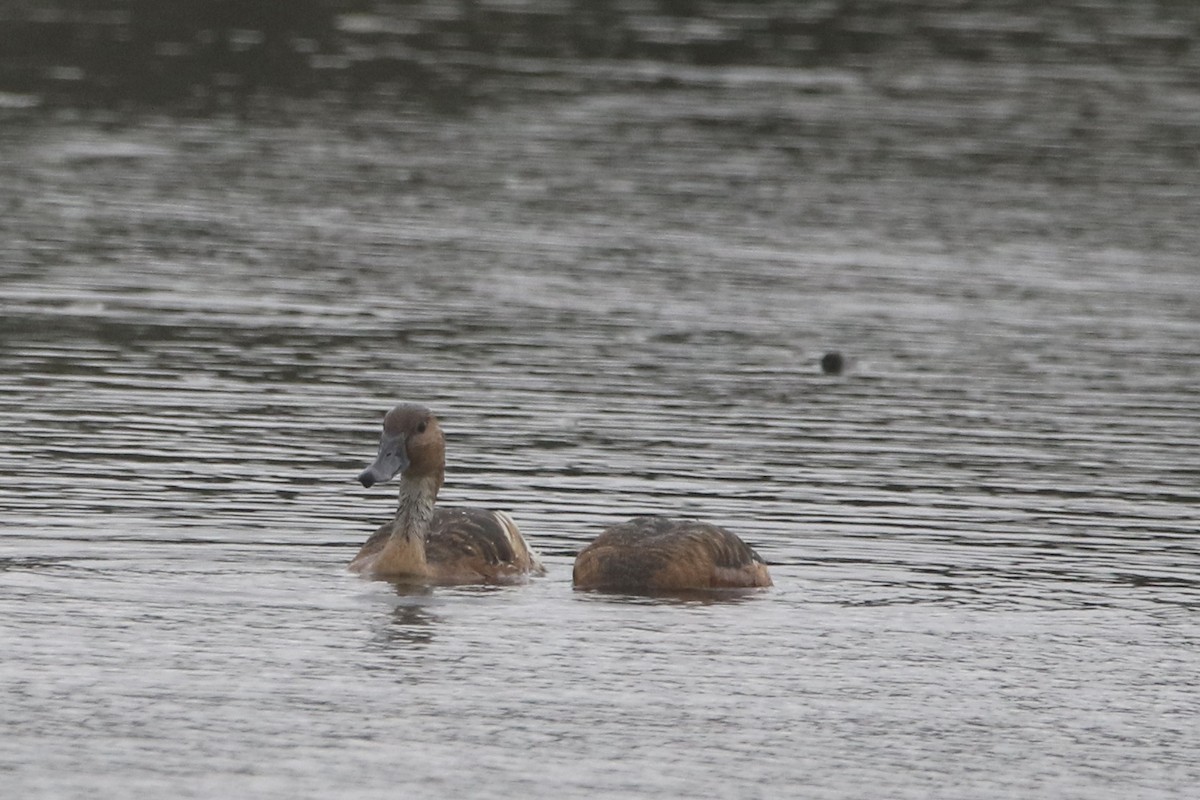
349 403 546 584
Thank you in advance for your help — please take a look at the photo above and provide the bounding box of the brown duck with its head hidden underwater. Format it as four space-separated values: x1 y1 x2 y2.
571 516 772 594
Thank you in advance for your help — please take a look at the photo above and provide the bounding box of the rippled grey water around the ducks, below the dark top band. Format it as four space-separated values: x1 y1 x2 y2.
0 59 1200 799
